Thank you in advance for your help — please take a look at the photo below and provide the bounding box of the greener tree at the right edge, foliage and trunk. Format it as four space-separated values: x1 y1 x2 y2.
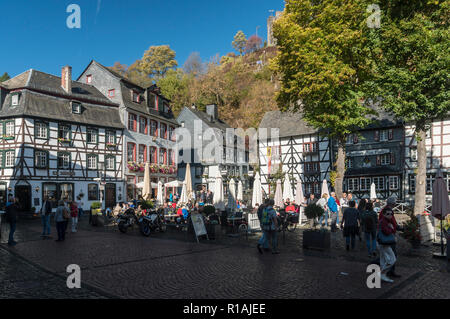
371 0 450 214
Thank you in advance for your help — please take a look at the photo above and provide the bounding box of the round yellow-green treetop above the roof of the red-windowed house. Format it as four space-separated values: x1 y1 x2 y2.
136 45 178 82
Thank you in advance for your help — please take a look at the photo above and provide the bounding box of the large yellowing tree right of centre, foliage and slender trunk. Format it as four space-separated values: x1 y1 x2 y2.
272 0 375 197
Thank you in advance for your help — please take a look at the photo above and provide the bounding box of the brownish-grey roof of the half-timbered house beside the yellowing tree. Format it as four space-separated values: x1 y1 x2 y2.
259 111 318 137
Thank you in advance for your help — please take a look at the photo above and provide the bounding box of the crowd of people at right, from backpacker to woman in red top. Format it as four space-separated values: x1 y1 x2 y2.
251 192 402 282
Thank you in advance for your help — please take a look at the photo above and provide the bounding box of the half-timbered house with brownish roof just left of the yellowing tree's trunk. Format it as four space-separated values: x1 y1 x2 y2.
258 111 331 199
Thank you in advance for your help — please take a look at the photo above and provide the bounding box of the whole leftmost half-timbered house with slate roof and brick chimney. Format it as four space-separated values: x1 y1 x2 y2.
0 66 124 211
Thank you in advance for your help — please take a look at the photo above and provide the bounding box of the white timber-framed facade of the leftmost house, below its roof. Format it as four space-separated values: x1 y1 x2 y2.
0 117 123 210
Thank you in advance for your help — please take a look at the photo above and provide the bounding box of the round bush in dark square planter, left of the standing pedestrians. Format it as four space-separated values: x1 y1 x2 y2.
303 204 331 250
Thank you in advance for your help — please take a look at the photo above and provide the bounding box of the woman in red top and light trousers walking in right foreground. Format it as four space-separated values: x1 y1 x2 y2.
377 208 397 282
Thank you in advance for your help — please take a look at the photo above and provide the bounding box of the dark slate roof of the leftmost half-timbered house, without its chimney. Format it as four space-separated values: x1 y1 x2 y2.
0 70 124 129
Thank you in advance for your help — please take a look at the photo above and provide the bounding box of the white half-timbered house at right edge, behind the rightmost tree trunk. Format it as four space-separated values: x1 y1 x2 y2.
404 114 450 204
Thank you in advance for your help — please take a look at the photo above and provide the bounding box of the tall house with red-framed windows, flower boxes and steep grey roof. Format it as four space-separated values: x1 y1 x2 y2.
78 61 178 200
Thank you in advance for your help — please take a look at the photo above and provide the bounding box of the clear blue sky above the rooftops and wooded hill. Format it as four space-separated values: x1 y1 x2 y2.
0 0 284 77
